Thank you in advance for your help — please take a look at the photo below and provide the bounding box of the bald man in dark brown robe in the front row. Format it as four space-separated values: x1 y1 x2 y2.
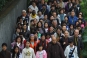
47 36 65 58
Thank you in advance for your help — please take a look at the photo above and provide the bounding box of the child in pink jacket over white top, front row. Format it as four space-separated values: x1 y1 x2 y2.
36 44 47 58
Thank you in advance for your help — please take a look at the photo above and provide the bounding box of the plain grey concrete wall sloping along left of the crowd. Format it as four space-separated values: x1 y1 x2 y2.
0 0 27 50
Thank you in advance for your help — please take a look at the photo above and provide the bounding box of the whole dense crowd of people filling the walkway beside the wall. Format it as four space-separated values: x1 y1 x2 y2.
0 0 85 58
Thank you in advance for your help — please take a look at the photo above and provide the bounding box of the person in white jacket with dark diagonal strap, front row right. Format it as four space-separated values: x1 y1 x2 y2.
64 40 79 58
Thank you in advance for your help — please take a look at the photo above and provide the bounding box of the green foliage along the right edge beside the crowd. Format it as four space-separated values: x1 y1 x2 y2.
80 0 87 58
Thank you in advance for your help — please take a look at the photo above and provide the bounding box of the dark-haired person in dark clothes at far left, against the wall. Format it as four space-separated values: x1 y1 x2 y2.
0 43 11 58
